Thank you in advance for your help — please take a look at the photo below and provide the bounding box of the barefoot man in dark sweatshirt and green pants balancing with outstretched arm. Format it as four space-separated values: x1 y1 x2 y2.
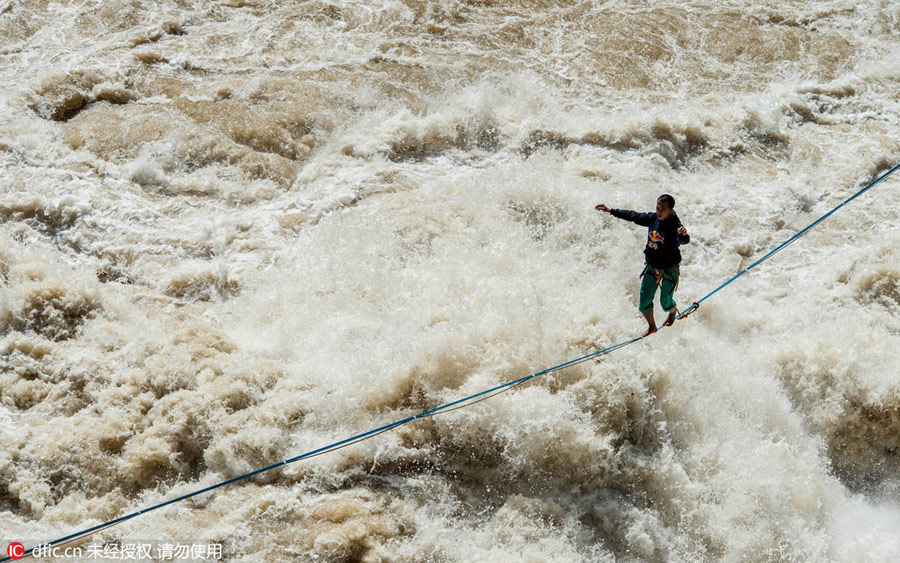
595 194 691 336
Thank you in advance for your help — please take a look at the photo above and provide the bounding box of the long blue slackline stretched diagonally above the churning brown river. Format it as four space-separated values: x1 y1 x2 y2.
0 164 900 563
